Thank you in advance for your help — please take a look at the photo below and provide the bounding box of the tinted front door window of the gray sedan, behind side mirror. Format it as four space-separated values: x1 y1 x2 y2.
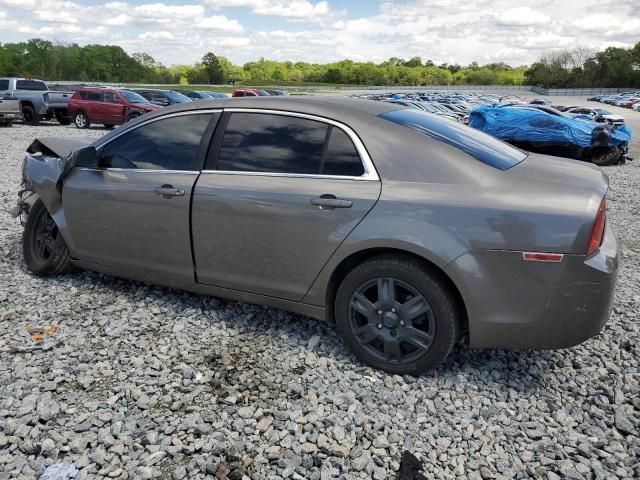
100 113 219 170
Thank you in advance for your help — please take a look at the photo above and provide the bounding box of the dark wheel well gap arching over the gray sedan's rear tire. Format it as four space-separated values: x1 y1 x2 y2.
325 248 469 335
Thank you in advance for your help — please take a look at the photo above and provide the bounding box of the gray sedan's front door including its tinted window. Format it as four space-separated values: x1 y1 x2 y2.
62 112 218 284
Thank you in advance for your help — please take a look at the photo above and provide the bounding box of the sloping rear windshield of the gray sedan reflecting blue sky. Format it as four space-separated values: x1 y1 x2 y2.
379 110 527 170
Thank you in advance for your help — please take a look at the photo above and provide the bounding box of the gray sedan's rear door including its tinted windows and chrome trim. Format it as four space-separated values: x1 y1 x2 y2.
192 109 380 300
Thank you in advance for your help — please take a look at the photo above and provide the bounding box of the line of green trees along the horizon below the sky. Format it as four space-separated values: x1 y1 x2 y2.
0 38 640 87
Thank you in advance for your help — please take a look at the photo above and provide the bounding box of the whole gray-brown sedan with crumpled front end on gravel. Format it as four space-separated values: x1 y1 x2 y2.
16 96 617 374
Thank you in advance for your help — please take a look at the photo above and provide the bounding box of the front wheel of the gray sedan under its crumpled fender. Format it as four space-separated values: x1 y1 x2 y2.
22 199 72 276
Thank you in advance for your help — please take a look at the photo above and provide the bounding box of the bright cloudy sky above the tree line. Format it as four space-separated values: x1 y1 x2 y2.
0 0 640 65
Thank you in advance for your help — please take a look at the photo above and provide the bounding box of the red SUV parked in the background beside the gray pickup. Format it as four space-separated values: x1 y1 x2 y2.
69 87 160 128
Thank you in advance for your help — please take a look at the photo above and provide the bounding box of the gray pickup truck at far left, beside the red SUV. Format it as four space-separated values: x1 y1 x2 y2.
0 77 73 125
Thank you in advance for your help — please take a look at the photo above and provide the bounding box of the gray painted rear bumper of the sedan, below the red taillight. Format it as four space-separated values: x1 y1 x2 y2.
446 226 618 349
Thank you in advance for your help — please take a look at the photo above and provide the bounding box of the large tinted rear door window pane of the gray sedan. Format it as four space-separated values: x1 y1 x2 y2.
217 113 328 174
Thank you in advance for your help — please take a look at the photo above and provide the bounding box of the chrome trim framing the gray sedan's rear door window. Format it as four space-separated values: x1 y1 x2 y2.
220 107 380 182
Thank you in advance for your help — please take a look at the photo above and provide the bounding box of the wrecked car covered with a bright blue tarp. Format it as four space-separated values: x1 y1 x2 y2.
469 105 631 166
